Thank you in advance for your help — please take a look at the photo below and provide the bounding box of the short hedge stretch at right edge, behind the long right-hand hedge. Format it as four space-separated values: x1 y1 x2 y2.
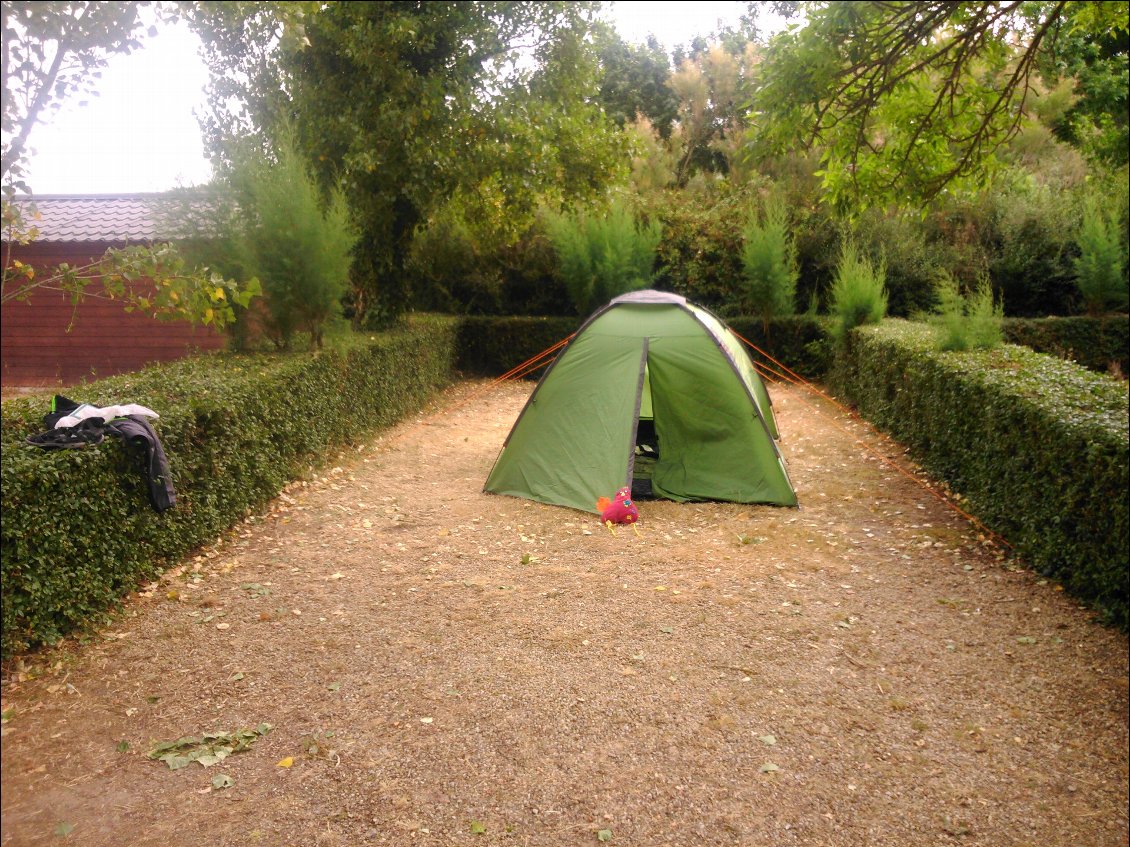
1003 315 1130 375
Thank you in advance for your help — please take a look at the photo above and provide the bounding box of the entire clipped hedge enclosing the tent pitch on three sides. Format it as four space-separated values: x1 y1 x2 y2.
0 316 1128 657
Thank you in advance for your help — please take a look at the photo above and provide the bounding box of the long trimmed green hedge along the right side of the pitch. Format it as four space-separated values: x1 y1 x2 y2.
833 321 1130 630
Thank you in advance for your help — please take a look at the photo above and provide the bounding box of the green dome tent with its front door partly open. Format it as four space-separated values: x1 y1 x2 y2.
485 290 797 512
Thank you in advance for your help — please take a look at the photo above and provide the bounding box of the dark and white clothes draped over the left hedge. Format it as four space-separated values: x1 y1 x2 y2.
27 394 176 512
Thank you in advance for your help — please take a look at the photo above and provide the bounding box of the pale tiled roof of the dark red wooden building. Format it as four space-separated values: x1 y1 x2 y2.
6 194 178 244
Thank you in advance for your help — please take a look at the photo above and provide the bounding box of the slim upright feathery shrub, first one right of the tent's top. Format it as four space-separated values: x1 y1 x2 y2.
741 198 800 333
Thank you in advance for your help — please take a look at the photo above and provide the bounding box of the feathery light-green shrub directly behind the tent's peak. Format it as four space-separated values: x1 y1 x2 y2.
546 201 661 315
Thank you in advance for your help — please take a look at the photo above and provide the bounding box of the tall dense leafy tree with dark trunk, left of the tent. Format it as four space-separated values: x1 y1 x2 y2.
197 0 619 318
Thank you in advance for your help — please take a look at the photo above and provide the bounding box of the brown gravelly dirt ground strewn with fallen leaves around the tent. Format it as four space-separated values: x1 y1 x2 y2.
0 383 1128 847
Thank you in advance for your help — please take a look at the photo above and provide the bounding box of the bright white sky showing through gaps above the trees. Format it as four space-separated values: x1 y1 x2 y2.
17 0 746 194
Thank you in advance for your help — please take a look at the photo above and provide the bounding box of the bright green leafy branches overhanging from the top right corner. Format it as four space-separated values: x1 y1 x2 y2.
753 0 1128 200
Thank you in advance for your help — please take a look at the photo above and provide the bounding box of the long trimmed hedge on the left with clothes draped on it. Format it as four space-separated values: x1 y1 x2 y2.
0 317 457 657
